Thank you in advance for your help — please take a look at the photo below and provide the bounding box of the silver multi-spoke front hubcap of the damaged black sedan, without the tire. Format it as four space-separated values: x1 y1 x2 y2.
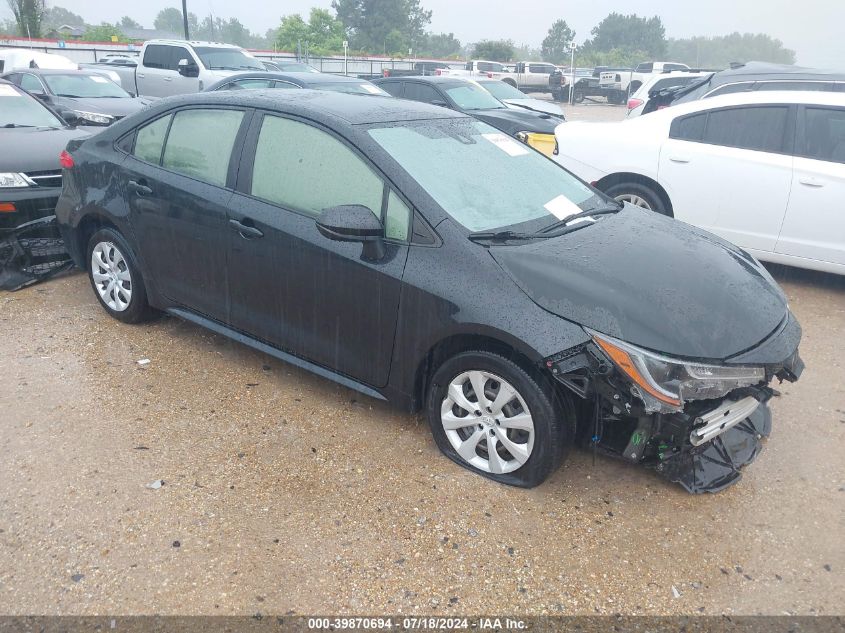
440 370 534 474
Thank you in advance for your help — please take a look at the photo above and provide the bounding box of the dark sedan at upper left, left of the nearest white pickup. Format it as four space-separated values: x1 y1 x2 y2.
3 68 149 125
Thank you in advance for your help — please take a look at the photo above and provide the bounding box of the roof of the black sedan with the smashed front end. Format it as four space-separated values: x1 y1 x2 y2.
144 89 466 125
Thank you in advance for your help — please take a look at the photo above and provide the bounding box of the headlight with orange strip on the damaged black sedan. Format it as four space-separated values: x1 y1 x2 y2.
590 332 766 409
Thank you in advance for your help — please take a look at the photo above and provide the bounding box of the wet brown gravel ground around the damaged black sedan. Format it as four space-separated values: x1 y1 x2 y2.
0 101 845 615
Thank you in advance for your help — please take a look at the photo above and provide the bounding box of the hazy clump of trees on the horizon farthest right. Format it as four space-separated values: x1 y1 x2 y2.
668 33 795 69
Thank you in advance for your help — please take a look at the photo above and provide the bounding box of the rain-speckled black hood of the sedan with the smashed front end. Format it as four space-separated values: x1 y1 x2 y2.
490 206 787 360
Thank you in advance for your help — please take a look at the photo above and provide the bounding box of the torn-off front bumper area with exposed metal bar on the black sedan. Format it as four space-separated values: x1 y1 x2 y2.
545 314 804 493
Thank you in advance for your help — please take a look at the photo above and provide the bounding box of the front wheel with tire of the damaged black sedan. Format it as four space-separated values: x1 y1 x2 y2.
426 352 575 488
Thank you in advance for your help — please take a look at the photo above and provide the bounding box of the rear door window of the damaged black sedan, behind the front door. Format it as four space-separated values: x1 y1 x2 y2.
162 108 244 187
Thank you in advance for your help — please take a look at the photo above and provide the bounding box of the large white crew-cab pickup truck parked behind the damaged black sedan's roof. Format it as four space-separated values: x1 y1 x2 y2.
97 40 264 97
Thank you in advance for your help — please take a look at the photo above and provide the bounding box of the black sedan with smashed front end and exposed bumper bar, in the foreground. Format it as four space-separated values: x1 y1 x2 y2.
57 90 802 492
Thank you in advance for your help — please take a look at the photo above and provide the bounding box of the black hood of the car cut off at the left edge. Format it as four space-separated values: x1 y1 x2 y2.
0 128 91 172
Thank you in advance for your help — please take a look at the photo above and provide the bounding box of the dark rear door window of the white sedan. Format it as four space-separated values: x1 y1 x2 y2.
703 106 789 152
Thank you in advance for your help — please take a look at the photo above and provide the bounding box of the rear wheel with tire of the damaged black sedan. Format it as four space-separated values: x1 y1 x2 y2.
86 228 154 323
